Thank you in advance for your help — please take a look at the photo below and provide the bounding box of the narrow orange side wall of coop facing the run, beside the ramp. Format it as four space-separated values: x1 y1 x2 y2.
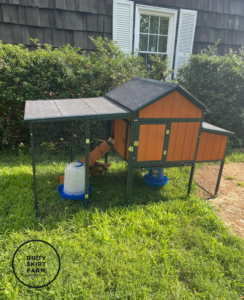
114 120 126 158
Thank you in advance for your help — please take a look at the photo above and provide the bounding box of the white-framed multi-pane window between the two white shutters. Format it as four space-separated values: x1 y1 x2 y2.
134 5 177 68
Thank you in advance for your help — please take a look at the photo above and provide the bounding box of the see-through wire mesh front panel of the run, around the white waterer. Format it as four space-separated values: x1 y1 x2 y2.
32 120 85 215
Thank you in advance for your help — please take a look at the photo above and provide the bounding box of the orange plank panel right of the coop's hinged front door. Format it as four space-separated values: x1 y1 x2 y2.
167 122 200 161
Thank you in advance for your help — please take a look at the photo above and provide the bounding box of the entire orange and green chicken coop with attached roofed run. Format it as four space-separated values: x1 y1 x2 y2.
24 77 233 216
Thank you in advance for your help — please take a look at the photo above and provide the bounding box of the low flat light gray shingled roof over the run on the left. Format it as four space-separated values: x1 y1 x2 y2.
24 97 130 121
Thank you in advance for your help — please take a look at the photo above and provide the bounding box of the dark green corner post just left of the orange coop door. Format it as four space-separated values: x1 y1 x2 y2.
125 116 136 205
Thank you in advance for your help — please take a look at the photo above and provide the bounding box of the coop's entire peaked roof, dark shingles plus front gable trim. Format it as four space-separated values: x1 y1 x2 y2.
106 77 211 112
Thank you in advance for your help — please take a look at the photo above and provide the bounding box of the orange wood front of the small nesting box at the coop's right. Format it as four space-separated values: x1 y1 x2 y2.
197 132 228 161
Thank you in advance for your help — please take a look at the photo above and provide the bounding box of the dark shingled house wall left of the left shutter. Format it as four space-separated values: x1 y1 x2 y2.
0 0 113 52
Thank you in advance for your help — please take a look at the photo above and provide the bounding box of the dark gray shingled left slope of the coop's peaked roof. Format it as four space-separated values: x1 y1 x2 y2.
105 78 175 111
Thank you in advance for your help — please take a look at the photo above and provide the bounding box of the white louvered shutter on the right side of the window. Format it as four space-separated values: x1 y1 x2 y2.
174 9 197 78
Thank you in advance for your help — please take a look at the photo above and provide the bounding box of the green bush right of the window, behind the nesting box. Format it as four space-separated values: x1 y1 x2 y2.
178 45 244 147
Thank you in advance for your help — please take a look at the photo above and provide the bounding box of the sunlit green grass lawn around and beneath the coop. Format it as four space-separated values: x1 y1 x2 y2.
0 152 244 300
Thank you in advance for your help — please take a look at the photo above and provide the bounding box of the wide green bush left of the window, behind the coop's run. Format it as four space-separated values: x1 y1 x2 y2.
0 38 145 148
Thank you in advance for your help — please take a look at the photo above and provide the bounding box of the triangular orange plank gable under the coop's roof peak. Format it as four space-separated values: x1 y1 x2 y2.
139 92 202 118
